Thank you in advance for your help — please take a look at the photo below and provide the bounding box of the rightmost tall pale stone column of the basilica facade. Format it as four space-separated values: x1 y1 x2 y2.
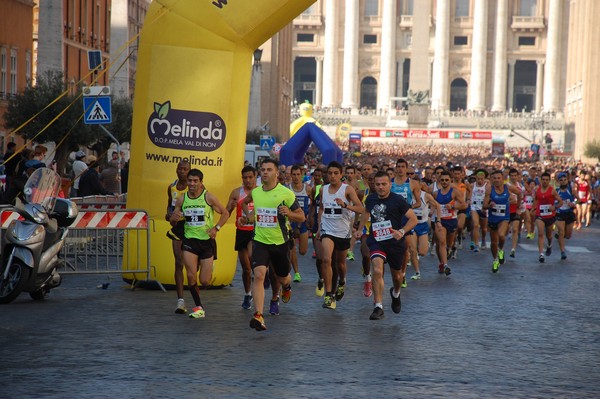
544 0 562 112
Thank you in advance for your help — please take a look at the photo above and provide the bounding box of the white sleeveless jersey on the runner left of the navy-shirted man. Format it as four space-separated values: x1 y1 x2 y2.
321 183 354 238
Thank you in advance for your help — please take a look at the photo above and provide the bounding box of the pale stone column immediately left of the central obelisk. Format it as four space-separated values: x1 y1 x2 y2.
377 0 396 110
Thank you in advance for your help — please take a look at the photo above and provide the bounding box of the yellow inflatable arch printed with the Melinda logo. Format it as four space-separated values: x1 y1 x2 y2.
123 0 315 286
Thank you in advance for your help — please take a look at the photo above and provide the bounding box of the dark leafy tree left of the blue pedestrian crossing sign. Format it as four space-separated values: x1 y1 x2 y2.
4 71 94 172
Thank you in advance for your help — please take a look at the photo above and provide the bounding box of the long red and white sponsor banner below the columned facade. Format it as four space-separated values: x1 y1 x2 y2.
361 129 492 140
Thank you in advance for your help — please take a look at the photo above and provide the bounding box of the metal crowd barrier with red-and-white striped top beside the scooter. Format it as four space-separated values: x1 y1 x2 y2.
0 209 166 292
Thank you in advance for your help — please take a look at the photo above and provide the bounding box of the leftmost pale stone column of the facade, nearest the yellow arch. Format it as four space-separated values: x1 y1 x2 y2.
322 0 338 107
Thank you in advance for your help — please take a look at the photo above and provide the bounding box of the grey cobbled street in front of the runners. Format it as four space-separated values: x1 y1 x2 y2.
0 226 600 398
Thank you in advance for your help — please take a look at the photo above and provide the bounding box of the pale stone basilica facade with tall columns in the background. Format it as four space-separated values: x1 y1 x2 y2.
293 0 569 113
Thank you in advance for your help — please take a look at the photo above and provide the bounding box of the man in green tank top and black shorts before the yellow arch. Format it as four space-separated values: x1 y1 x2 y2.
171 169 229 319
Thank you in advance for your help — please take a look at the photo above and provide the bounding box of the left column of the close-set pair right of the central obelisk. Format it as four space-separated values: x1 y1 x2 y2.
468 0 488 111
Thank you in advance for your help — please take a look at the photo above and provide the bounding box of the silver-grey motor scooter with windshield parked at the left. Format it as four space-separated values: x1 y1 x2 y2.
0 168 78 304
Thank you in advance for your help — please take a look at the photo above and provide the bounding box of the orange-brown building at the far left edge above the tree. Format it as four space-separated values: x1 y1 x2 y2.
0 0 34 152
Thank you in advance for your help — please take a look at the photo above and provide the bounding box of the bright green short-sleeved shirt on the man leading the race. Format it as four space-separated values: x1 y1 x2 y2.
252 183 298 245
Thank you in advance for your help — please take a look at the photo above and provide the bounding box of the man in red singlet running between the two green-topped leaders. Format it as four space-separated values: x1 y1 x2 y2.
227 165 256 309
